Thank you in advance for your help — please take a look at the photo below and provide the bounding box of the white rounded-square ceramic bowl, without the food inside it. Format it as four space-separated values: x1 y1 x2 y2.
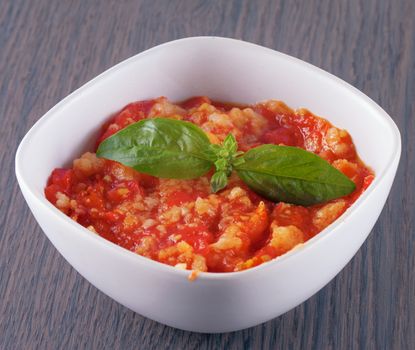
16 37 401 333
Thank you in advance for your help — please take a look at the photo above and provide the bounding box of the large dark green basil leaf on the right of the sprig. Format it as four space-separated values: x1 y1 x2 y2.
234 145 355 205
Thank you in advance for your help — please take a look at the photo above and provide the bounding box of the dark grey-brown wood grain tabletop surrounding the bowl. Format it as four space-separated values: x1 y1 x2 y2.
0 0 415 349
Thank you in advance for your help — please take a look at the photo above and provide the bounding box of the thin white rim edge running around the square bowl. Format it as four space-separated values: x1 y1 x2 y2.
15 36 401 280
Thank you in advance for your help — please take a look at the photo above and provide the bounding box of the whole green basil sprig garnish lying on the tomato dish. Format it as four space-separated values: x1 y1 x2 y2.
97 118 355 205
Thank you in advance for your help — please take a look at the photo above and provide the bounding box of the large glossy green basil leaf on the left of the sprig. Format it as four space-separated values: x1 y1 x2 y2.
97 118 214 179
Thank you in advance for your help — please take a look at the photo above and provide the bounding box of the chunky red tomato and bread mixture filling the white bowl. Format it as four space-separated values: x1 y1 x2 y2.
45 97 374 272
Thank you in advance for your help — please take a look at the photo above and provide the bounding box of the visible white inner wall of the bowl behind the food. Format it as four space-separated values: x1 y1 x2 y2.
16 37 400 216
